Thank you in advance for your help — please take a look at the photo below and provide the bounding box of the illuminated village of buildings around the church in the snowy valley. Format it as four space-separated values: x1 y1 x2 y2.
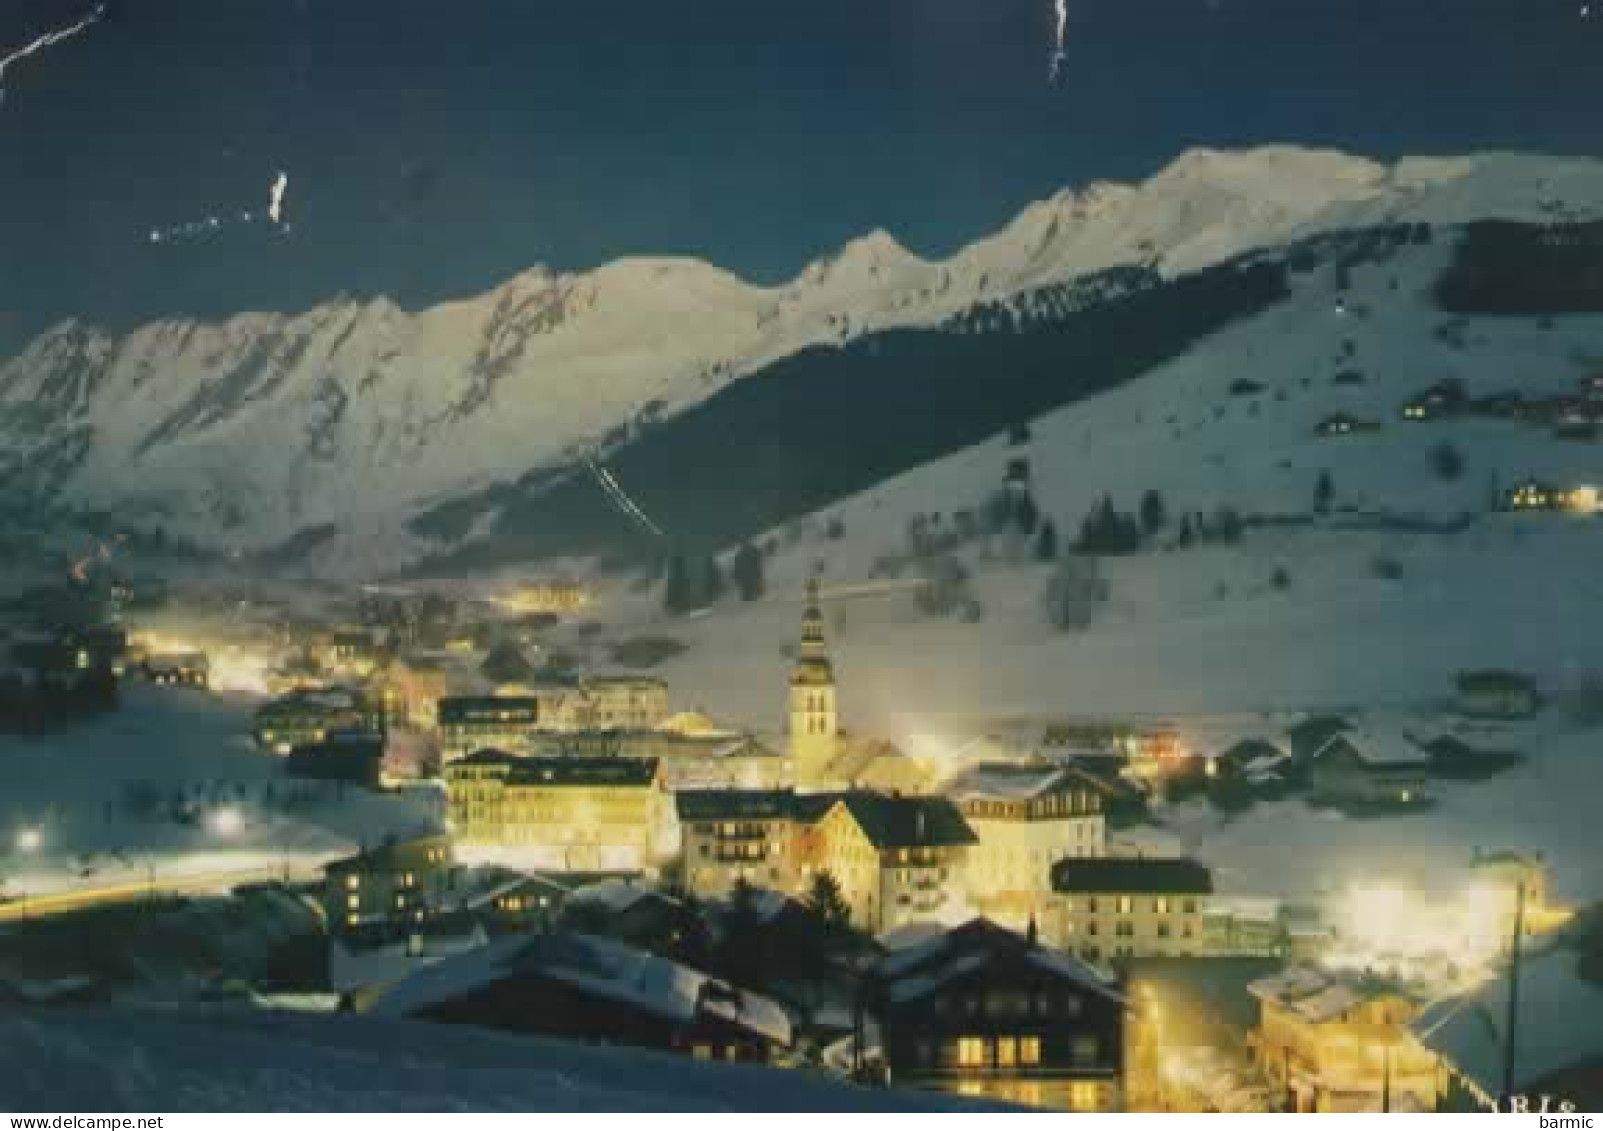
0 560 1603 1112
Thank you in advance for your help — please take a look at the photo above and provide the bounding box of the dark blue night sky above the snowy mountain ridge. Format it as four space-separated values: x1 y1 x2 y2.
0 0 1603 338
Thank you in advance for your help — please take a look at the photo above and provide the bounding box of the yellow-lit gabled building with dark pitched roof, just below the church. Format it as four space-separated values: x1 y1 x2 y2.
797 790 978 934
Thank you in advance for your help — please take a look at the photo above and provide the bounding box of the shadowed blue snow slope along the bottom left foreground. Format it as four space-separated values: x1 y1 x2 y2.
0 1009 984 1113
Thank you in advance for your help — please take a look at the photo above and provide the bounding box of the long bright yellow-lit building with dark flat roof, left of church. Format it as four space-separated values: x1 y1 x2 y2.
446 750 667 871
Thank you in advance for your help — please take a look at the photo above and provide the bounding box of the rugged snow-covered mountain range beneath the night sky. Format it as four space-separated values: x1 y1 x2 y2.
0 147 1603 564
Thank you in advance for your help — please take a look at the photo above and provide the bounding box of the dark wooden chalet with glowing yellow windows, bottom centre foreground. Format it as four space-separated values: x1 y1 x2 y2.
869 920 1125 1112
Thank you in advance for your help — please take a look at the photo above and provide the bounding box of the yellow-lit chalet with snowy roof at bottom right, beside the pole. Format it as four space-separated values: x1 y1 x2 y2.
1249 966 1442 1113
